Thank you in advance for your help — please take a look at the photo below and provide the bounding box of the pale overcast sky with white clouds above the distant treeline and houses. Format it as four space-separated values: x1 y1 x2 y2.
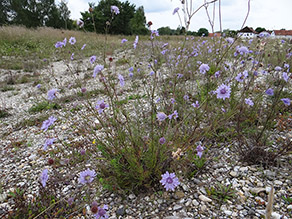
57 0 292 31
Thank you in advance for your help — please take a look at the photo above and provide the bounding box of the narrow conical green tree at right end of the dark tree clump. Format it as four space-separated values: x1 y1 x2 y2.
130 6 149 35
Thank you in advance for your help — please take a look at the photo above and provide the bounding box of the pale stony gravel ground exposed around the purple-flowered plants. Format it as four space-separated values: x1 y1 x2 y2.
0 58 292 219
